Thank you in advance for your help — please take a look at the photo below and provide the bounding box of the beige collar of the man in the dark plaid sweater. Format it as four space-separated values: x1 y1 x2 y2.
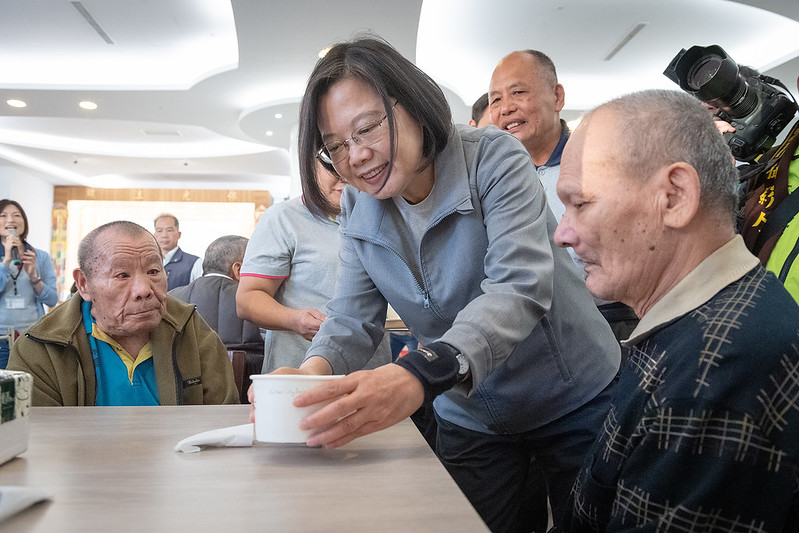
622 235 760 346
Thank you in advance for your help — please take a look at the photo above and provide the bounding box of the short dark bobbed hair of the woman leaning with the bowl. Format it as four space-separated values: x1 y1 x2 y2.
299 36 452 217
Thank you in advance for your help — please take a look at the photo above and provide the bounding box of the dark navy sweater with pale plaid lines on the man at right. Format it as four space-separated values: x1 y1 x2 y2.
561 266 799 532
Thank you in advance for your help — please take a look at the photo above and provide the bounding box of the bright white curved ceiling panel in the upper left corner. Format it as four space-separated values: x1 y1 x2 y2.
0 0 238 90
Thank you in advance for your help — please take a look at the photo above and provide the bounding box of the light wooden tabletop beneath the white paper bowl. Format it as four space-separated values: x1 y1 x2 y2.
0 405 487 533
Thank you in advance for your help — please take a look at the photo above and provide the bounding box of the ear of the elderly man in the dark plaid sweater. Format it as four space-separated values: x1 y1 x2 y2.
658 162 699 229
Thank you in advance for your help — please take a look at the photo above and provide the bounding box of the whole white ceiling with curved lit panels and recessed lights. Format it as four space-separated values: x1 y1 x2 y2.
0 0 799 198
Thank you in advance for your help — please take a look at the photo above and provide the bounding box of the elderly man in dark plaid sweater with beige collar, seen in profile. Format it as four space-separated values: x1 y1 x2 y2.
555 91 799 532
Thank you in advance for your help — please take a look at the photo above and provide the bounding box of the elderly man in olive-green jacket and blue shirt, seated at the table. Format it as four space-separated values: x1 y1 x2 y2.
8 221 238 405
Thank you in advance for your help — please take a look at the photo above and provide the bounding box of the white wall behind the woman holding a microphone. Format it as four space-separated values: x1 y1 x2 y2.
0 160 53 249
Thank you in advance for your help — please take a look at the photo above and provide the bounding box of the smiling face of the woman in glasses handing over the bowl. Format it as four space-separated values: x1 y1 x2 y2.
319 78 433 203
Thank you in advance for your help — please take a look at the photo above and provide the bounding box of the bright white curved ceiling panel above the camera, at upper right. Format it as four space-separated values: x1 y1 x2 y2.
416 0 799 109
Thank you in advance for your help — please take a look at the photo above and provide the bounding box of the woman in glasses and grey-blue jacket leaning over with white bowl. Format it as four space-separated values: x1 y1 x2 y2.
248 38 620 531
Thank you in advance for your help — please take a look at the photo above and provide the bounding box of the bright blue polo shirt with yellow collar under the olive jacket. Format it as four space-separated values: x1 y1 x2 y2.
81 301 160 405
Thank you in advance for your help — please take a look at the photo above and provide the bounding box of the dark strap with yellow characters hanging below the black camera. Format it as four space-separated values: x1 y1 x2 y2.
741 123 799 265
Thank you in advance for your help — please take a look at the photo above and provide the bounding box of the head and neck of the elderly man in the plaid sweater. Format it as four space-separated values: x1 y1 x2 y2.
554 91 738 316
